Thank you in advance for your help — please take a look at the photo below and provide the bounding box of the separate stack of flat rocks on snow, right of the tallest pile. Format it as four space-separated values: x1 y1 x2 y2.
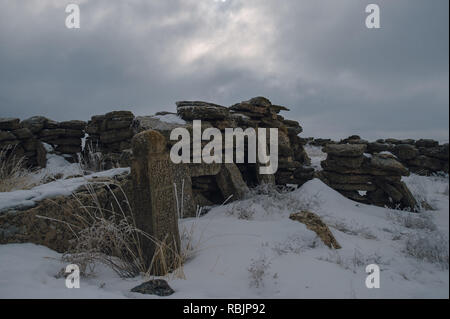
318 144 417 210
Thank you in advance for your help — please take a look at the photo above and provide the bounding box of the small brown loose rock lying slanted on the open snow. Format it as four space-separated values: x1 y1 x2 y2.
289 211 341 249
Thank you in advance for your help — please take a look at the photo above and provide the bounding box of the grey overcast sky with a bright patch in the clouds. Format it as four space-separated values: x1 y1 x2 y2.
0 0 449 141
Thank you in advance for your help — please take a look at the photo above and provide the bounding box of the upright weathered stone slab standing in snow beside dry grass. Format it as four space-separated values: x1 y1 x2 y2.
131 130 180 275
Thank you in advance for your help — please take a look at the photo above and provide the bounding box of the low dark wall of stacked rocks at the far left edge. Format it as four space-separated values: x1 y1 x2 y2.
0 116 86 167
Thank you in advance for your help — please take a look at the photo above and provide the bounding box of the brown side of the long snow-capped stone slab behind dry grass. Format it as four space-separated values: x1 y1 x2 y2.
0 176 131 253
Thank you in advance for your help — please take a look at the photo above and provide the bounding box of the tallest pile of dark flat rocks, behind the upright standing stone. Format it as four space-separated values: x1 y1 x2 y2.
176 97 314 186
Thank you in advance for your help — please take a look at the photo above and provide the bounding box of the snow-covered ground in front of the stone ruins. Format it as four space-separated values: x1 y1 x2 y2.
0 151 449 298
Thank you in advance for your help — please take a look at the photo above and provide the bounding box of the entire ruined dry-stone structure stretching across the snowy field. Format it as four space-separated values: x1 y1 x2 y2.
0 97 449 268
